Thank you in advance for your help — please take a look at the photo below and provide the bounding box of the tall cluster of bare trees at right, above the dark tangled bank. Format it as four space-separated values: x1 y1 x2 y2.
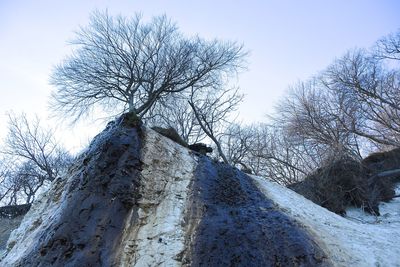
253 29 400 184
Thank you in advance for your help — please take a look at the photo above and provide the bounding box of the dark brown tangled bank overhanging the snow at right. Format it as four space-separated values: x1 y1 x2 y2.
289 149 400 215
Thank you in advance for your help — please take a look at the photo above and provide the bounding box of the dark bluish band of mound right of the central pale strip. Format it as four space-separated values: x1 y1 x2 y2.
182 157 329 266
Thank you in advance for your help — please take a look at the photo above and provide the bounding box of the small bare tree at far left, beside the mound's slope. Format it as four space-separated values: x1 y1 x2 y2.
1 114 72 205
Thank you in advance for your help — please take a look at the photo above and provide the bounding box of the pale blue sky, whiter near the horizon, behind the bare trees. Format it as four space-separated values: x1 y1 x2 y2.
0 0 400 153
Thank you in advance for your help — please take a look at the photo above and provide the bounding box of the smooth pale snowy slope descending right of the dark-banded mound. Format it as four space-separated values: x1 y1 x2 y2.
252 176 400 267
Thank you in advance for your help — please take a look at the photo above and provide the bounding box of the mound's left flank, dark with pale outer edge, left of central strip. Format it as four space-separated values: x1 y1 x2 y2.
2 114 142 266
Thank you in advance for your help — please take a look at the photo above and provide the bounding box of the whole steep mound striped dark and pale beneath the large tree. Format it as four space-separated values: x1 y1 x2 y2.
0 115 328 266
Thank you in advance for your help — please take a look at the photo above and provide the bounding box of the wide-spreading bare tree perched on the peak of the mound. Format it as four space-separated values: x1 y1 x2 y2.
51 12 246 122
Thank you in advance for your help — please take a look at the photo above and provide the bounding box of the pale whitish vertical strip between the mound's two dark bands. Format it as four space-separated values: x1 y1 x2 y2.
122 129 196 266
